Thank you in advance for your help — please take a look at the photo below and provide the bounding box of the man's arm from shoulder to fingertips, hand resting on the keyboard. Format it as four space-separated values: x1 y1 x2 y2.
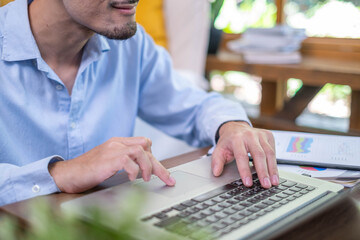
139 26 278 188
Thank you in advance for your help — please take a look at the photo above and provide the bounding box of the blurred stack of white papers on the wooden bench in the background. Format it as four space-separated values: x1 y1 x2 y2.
228 25 306 64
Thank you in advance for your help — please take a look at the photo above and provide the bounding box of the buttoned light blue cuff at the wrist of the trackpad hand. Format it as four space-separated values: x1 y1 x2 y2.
9 156 64 201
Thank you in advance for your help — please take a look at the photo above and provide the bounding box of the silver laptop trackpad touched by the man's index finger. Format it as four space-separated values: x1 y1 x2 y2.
138 171 211 197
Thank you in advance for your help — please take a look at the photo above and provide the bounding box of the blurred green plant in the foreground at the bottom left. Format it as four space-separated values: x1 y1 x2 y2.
0 188 165 240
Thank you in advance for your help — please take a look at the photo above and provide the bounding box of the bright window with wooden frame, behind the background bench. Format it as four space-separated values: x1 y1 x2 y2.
210 0 360 131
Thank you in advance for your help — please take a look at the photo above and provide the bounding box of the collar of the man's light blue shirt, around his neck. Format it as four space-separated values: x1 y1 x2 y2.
1 0 110 61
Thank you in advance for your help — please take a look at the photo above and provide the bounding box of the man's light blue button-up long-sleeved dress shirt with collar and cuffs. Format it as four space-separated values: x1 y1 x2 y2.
0 0 248 205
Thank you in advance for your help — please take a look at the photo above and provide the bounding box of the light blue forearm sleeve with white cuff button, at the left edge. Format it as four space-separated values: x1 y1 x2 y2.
0 156 63 206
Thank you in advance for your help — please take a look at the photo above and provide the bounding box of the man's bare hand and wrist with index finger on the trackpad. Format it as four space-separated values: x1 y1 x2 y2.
49 137 175 193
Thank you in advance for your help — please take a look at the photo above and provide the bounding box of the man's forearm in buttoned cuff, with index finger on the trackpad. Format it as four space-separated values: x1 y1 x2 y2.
0 137 175 206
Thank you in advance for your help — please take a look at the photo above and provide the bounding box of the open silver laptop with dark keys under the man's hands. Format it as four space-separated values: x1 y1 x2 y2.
61 157 344 239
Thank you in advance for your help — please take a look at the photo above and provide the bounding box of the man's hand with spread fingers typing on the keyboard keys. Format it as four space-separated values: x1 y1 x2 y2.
212 122 279 188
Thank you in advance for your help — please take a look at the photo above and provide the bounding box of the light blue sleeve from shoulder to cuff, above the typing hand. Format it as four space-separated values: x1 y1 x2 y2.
139 28 250 147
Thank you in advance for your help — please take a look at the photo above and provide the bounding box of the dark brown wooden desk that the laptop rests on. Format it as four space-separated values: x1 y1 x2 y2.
0 148 360 240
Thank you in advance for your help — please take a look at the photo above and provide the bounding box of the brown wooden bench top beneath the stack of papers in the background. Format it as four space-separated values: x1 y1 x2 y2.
206 50 360 90
